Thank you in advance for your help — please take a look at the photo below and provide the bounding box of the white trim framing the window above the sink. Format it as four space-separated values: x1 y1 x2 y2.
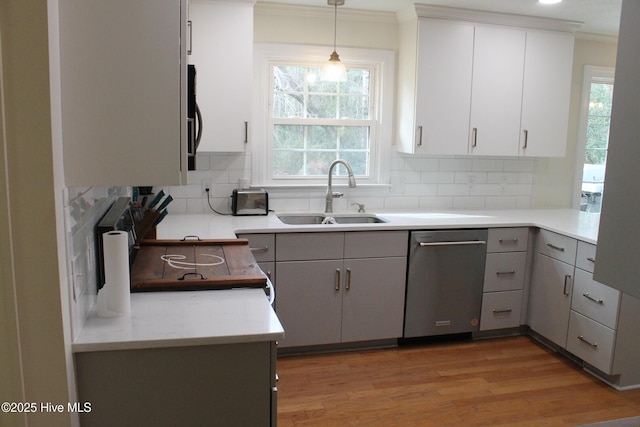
249 43 395 188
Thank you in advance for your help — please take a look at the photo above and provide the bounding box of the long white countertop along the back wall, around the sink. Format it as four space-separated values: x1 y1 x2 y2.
157 209 600 243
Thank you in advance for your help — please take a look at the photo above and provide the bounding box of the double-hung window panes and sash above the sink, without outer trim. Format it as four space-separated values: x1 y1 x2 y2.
270 64 376 179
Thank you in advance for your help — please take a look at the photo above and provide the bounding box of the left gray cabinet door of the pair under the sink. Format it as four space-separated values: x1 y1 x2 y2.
276 260 345 348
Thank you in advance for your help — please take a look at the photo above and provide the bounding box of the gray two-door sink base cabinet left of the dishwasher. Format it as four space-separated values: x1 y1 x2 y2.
276 231 408 348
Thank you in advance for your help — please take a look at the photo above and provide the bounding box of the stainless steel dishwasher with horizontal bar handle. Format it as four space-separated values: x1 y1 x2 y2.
404 229 487 338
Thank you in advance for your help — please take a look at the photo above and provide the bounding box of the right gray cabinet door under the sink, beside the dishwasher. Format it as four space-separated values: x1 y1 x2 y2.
342 257 406 342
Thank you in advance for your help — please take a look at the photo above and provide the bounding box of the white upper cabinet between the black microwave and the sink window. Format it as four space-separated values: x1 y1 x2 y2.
189 0 255 153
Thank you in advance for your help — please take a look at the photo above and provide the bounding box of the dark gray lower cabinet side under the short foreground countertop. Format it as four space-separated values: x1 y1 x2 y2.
74 342 277 427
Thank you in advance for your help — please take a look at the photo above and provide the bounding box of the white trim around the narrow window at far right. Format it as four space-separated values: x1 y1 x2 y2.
572 65 615 209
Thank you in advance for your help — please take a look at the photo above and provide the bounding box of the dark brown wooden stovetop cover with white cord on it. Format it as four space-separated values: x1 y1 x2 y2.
131 239 267 292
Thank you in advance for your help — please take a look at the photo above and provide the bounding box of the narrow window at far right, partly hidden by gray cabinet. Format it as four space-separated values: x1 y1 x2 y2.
576 66 614 213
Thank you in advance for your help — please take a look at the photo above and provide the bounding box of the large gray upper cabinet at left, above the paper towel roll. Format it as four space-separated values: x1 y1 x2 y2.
55 0 187 187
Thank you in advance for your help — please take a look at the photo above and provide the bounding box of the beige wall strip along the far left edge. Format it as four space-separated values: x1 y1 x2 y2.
0 0 75 426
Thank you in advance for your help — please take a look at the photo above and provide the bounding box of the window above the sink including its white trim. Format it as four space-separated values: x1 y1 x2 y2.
252 46 393 186
